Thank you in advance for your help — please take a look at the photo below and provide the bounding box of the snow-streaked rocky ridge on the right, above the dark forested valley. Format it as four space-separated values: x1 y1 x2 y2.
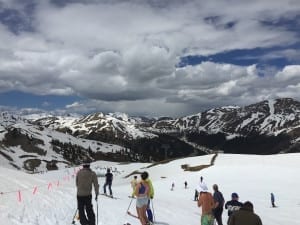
153 98 300 137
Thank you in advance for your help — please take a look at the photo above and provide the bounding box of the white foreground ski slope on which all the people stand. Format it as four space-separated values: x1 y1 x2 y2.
0 154 300 225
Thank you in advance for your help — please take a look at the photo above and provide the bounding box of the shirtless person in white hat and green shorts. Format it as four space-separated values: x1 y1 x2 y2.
197 187 214 225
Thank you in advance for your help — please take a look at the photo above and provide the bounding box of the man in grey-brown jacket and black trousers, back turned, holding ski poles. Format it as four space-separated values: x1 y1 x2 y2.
76 162 99 225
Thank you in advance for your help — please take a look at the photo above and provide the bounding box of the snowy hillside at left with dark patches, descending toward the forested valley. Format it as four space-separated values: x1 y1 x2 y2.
0 116 123 171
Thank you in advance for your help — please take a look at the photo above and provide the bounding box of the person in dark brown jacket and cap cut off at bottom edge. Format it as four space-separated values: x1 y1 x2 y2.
228 201 262 225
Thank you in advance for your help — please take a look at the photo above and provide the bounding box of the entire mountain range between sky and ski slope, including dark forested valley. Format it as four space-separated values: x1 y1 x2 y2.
0 98 300 171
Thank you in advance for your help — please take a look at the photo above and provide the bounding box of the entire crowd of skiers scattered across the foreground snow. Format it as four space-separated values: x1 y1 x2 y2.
76 163 268 225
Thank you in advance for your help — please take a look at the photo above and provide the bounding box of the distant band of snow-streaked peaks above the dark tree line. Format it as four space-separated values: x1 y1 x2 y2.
28 98 300 139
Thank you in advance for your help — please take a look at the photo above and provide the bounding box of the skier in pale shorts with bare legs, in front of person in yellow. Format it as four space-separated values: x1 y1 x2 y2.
135 172 150 225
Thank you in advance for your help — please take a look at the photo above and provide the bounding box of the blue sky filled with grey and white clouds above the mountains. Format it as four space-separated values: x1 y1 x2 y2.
0 0 300 116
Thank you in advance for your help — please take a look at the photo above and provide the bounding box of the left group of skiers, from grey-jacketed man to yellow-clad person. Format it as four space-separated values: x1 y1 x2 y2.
76 162 154 225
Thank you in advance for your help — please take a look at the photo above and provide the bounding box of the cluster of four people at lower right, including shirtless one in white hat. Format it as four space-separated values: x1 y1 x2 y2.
197 177 262 225
